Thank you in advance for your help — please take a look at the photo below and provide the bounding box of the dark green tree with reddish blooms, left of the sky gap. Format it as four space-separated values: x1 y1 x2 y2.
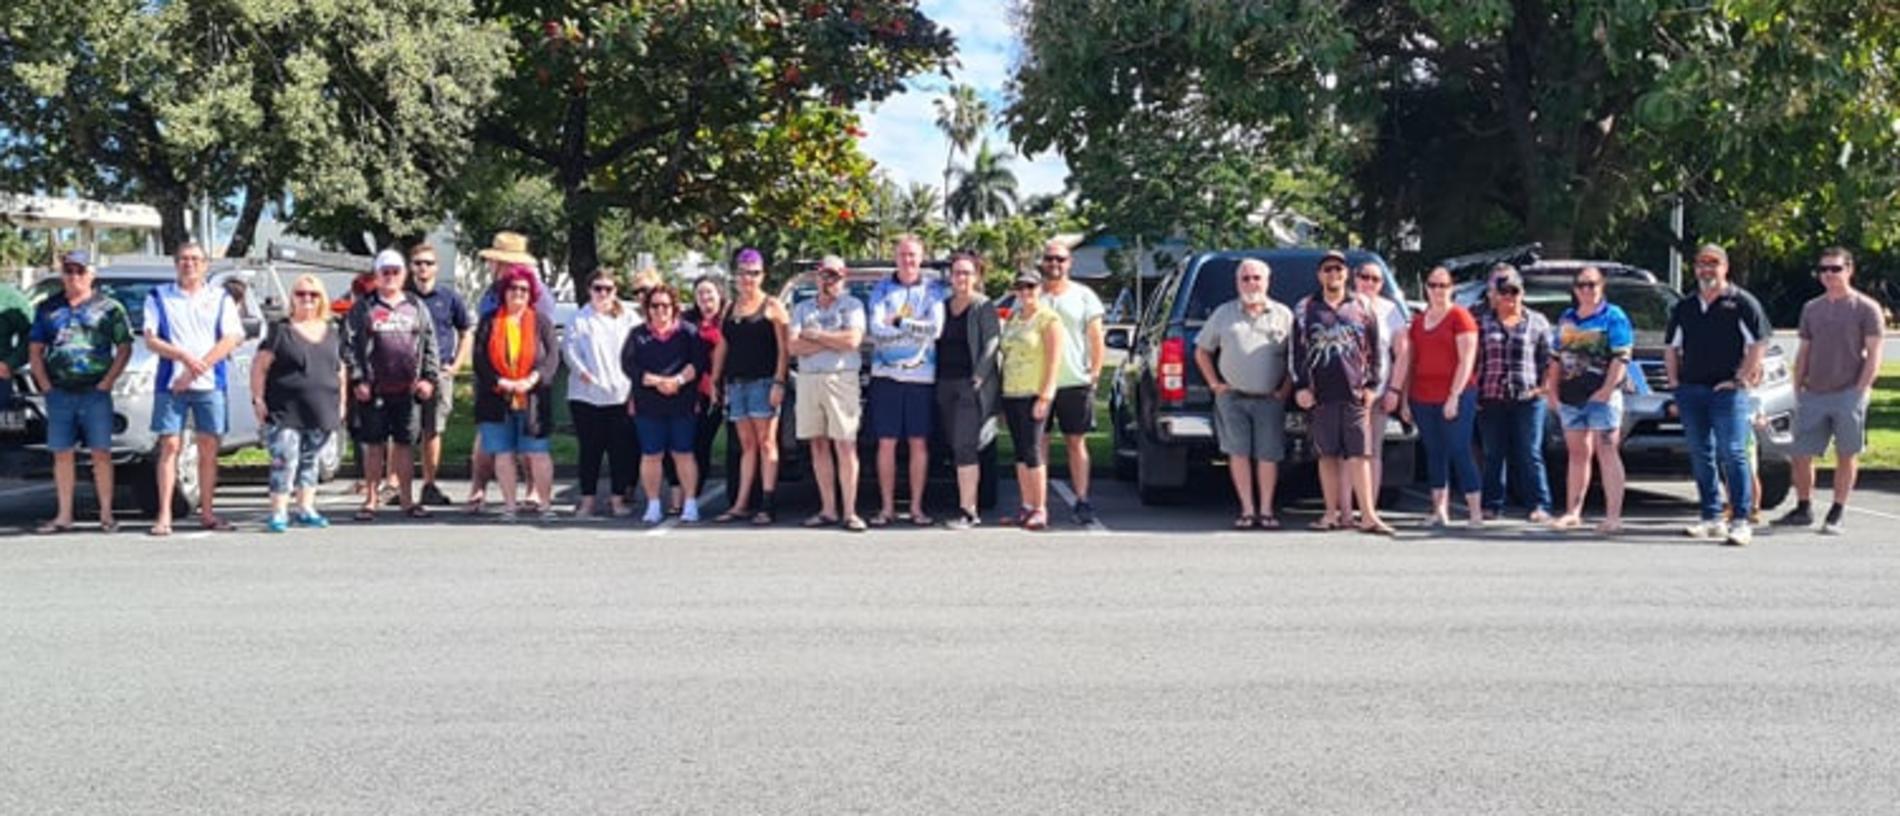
479 0 952 285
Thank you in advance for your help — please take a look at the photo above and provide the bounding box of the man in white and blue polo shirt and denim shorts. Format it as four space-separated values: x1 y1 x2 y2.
144 243 243 536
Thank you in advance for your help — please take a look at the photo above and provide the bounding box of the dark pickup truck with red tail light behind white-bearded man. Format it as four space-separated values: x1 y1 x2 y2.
1108 249 1417 504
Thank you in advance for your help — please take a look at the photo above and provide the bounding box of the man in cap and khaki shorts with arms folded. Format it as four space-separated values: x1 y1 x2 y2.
787 255 865 533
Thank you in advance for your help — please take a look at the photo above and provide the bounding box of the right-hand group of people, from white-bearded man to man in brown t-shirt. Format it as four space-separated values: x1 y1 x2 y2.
1195 245 1881 544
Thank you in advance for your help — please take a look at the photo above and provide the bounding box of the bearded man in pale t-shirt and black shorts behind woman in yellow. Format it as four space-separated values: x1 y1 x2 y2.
1041 242 1108 525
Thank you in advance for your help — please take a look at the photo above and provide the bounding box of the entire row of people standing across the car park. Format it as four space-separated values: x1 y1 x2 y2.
8 234 1883 544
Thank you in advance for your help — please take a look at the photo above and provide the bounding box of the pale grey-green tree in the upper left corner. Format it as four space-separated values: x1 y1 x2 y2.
0 0 505 251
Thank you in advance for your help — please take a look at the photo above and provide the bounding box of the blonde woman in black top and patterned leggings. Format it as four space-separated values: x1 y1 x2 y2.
251 274 344 533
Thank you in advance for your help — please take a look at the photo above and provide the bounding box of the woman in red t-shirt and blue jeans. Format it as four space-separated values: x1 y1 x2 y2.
1385 266 1484 527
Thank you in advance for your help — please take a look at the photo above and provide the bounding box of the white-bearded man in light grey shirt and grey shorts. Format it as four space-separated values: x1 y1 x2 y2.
1193 259 1294 529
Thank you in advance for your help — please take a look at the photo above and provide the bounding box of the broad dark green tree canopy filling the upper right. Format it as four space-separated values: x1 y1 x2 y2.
1005 0 1900 260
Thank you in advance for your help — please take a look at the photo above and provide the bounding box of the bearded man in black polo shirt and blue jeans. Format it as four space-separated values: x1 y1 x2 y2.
1663 243 1775 546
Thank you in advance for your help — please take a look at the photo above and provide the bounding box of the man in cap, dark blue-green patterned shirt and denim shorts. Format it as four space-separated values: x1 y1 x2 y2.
30 251 131 533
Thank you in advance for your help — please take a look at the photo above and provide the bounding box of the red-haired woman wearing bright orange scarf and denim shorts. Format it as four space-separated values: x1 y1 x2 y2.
475 266 561 521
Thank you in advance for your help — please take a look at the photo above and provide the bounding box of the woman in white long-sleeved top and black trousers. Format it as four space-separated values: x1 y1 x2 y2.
562 268 638 519
